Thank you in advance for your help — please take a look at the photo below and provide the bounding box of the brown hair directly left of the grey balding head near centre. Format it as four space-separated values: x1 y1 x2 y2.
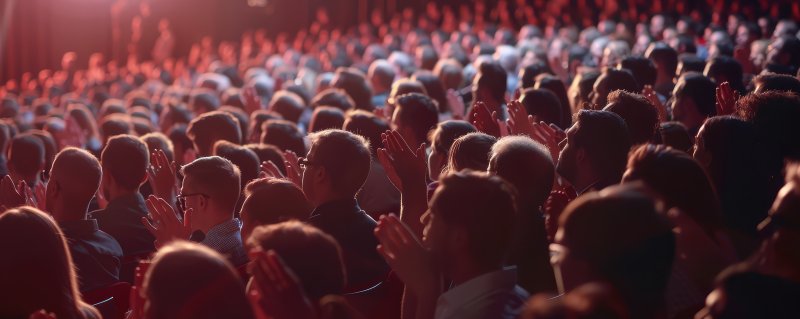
447 132 497 172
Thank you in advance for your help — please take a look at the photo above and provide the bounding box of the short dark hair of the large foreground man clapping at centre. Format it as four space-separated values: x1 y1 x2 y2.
430 172 517 267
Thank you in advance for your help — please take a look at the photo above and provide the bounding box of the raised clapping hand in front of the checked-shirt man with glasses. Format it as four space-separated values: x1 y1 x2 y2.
142 195 192 248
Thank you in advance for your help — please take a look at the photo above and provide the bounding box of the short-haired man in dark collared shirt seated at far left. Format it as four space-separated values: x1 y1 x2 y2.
44 148 123 292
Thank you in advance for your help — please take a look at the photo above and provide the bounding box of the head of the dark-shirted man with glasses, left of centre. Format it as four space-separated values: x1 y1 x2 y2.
303 130 371 207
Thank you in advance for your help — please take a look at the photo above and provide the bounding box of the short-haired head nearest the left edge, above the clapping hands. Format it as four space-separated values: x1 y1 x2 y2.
8 134 45 180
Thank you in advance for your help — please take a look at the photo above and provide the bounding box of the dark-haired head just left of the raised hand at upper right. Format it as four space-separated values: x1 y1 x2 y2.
672 72 717 137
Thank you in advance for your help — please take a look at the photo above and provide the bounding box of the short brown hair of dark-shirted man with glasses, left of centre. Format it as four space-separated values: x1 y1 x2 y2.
309 130 371 196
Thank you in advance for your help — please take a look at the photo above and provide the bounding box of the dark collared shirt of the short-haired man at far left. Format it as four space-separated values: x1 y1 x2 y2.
59 219 122 291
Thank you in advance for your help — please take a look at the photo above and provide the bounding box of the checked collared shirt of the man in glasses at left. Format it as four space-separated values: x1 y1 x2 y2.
200 218 247 266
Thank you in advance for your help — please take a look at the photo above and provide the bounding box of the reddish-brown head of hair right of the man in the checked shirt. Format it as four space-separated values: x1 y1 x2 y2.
239 177 312 243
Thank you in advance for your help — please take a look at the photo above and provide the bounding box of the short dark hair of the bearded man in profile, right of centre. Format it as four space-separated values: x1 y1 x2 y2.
574 110 631 180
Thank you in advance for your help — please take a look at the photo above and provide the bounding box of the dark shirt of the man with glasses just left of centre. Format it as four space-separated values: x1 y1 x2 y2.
308 199 389 291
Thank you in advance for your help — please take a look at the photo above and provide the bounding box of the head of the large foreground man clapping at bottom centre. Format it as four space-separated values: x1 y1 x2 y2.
422 172 517 282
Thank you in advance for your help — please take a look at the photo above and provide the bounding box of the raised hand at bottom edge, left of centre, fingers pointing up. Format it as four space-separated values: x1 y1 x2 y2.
247 250 316 319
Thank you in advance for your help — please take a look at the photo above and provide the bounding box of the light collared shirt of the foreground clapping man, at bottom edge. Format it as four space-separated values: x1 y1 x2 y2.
435 267 528 319
